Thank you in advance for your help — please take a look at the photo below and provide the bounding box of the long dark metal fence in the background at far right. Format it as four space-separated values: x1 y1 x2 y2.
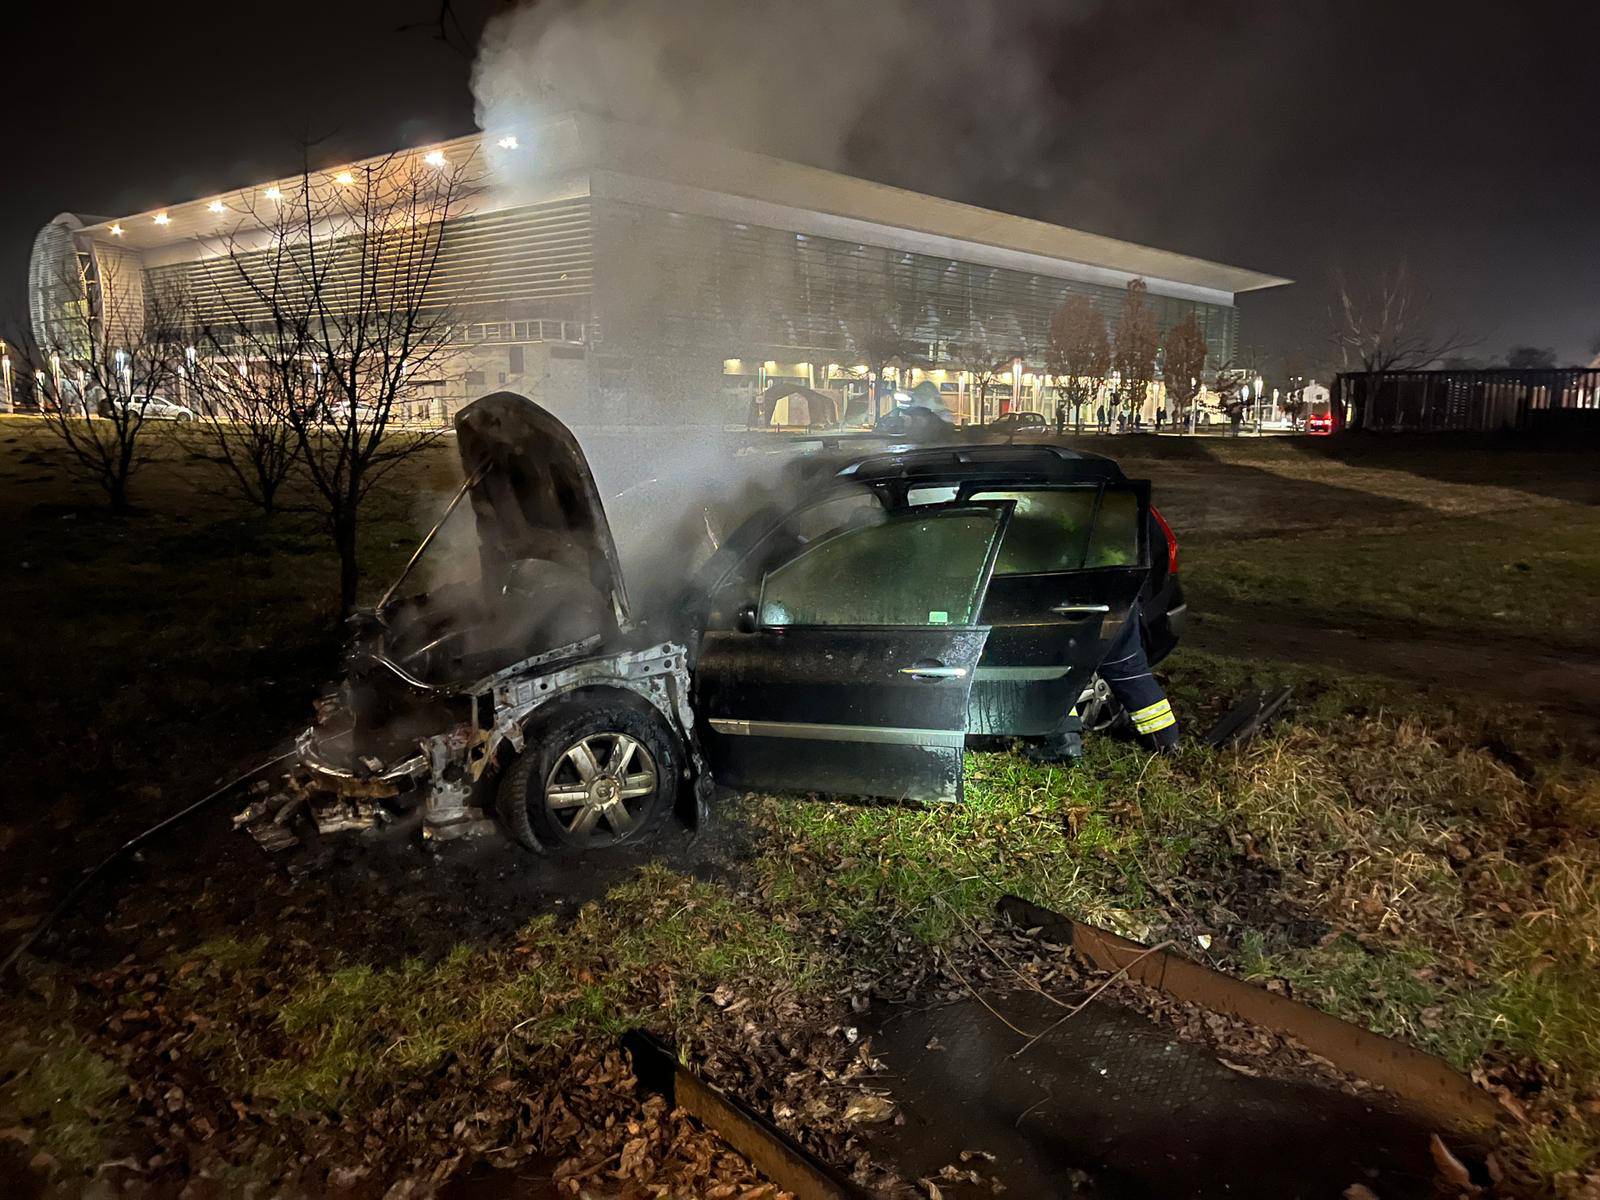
1331 374 1600 432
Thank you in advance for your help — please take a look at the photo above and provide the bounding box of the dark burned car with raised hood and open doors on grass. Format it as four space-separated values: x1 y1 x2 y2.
299 392 1184 851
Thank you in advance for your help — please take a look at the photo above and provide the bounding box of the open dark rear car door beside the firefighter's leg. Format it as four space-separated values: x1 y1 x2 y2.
968 483 1149 738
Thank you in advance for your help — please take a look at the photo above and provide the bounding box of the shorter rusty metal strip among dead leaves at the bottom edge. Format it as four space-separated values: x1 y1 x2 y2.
622 1029 862 1200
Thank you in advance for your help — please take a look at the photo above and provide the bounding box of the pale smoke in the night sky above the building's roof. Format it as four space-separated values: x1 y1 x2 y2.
472 0 1098 181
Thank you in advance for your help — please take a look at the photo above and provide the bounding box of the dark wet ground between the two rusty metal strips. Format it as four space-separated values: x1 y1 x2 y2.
872 990 1434 1200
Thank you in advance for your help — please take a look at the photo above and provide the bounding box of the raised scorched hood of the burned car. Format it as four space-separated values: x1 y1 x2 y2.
456 392 629 622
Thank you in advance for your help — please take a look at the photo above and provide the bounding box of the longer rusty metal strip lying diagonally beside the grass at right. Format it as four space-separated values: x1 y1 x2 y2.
998 896 1499 1131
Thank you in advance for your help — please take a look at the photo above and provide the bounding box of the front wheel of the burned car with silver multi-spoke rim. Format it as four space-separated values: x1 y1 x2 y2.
496 694 682 854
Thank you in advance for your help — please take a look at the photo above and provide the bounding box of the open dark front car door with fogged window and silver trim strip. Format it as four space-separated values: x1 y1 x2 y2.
694 501 1013 802
